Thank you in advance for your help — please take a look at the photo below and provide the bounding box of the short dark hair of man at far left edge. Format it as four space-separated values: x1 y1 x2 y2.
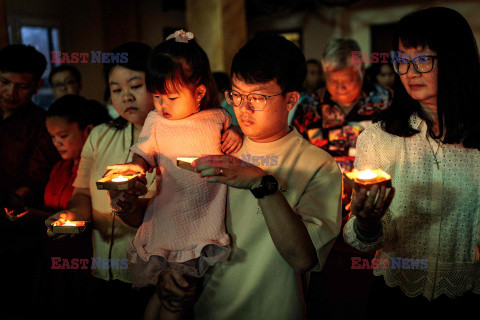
0 44 47 82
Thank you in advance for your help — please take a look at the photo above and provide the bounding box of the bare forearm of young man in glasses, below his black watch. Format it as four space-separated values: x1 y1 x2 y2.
258 191 318 273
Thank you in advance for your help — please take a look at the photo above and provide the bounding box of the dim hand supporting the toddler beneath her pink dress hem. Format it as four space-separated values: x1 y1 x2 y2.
156 269 197 312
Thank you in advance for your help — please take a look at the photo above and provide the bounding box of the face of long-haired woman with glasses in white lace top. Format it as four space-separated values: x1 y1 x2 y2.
399 42 438 105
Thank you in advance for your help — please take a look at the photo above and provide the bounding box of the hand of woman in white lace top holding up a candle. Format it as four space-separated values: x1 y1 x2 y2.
351 185 395 234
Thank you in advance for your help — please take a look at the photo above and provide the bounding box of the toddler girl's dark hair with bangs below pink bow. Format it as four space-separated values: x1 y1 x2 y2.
146 38 220 110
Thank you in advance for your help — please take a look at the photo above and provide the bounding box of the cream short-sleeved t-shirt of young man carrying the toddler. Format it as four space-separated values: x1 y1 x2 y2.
195 129 342 320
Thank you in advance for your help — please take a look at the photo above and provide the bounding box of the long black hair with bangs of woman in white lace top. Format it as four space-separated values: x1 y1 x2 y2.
381 7 480 149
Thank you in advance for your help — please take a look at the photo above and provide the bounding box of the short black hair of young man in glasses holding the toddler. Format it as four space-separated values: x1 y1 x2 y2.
231 34 307 93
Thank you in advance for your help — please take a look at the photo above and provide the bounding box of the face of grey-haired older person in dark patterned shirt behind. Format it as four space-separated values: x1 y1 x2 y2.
325 66 363 104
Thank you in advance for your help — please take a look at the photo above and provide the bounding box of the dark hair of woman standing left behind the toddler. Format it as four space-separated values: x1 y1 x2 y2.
103 42 152 129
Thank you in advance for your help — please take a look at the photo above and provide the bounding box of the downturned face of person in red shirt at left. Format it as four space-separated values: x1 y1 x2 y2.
45 117 89 163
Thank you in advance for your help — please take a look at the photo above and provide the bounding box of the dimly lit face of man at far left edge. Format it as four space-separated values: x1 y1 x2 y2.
0 72 43 110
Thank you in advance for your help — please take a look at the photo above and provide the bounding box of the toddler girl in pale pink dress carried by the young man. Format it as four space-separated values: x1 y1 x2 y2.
108 31 242 319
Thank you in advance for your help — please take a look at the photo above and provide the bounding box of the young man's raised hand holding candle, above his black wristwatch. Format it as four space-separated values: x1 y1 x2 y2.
193 155 267 190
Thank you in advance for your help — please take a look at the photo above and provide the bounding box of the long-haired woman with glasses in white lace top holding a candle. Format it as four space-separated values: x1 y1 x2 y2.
344 8 480 318
